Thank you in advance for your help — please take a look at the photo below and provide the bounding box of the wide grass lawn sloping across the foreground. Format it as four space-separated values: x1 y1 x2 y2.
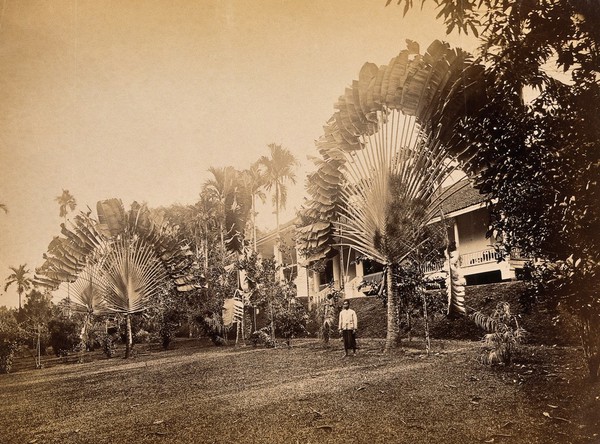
0 339 600 444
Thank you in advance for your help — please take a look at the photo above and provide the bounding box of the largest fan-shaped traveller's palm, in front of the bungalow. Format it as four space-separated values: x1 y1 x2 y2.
299 41 478 350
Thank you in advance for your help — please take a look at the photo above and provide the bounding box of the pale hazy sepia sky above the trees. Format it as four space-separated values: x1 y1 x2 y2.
0 0 474 306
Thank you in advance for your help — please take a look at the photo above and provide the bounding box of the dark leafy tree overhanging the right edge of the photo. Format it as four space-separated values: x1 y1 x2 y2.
388 0 600 377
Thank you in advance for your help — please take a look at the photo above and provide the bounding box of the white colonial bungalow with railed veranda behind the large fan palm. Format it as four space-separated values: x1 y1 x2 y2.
257 181 525 304
